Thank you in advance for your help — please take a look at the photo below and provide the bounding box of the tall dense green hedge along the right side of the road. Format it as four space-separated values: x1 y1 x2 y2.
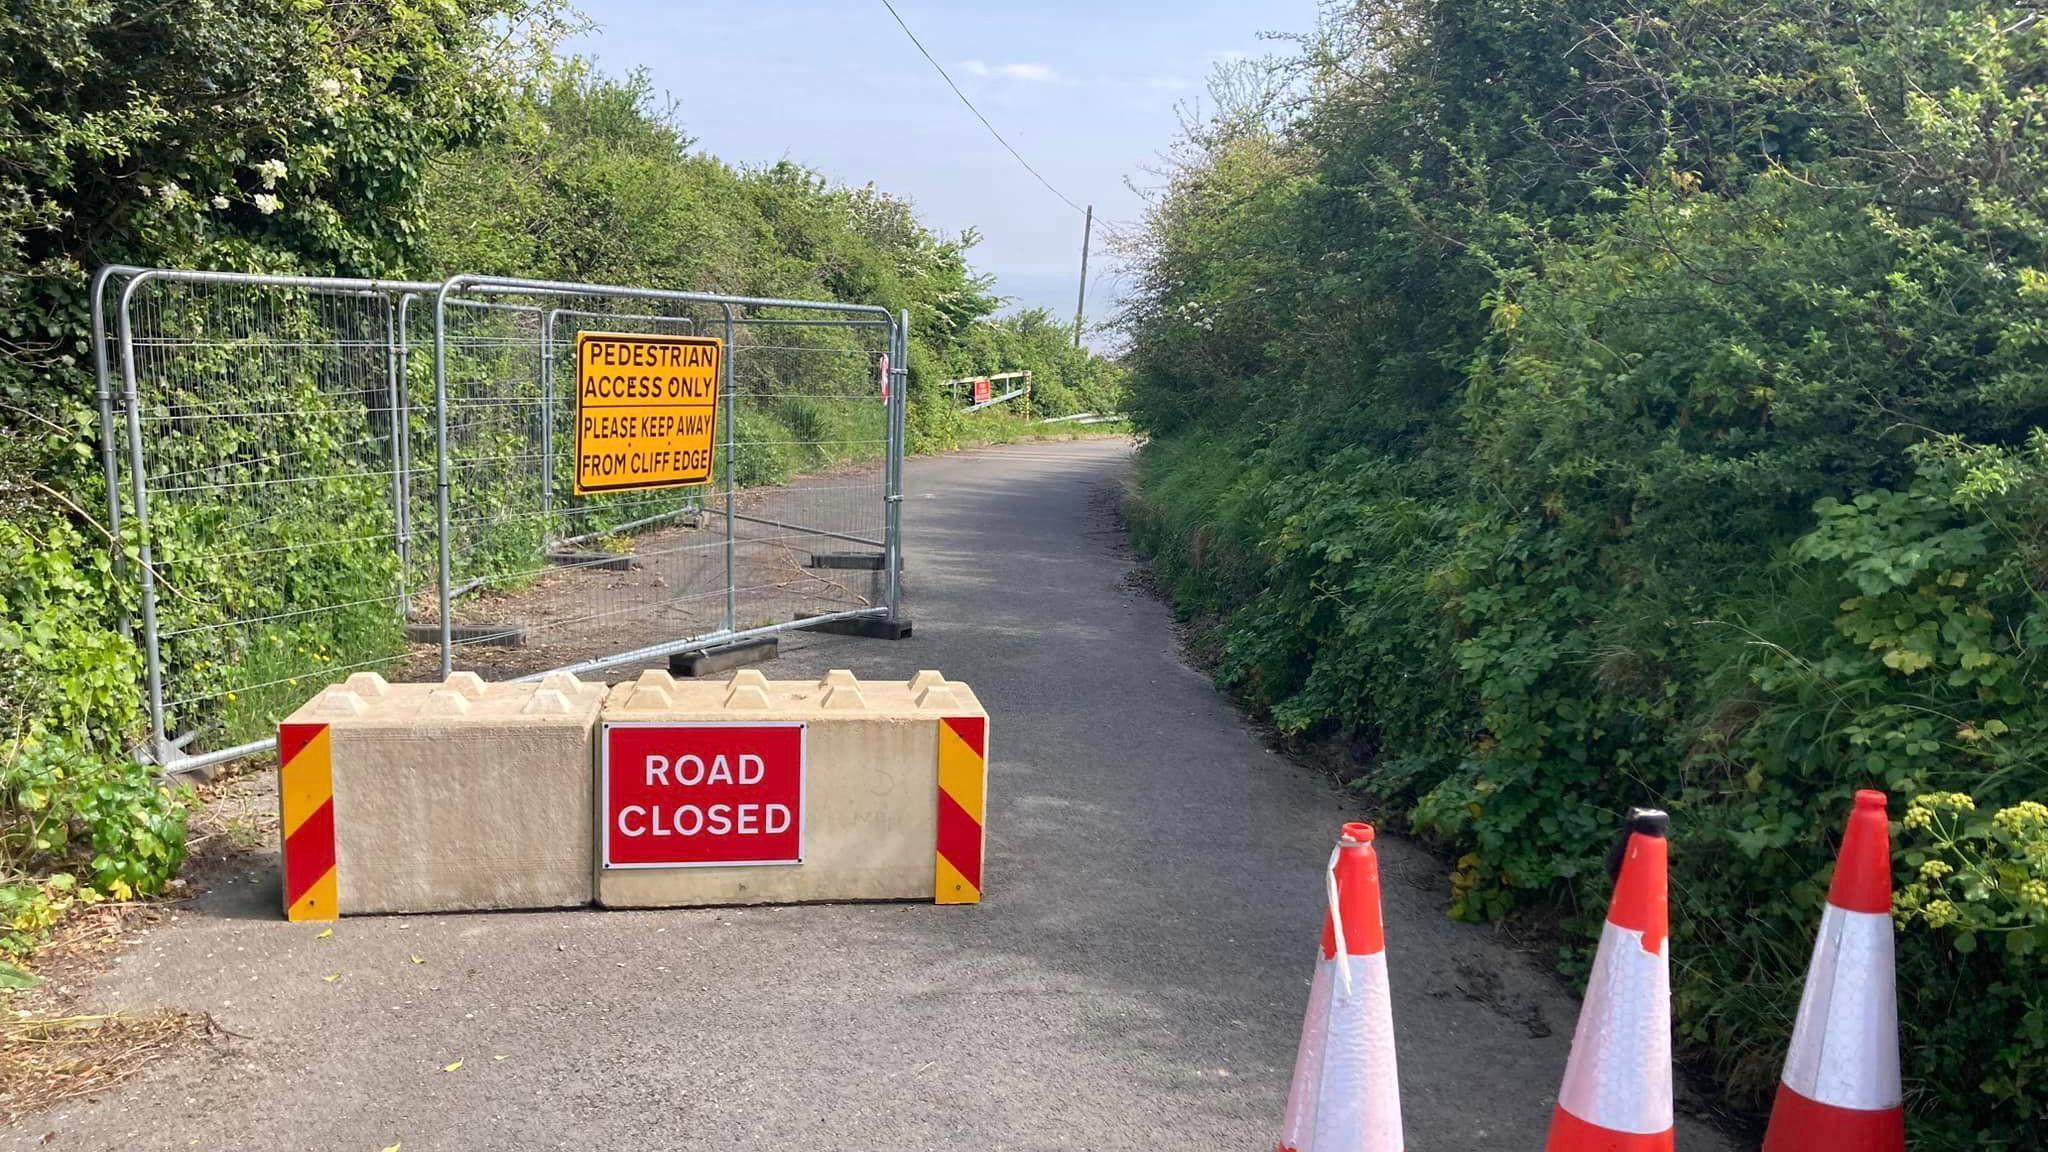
1126 0 2048 1148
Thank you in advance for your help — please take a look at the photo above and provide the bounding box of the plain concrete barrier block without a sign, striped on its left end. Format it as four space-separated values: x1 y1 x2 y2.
279 672 606 920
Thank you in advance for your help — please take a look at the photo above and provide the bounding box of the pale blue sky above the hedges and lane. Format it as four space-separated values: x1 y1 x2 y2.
571 0 1315 320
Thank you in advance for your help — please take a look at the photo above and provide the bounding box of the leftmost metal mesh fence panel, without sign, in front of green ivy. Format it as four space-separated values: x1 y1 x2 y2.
109 271 440 758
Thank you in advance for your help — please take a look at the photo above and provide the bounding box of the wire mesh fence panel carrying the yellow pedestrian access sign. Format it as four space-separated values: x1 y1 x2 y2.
419 277 897 676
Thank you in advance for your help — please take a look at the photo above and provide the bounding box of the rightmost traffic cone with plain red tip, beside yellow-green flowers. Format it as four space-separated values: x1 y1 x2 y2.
1763 789 1907 1152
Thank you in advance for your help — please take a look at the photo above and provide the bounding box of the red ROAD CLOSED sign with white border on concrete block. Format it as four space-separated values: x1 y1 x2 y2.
598 722 805 867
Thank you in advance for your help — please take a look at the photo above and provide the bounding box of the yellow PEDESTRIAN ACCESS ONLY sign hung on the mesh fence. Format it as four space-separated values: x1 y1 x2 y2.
575 332 725 494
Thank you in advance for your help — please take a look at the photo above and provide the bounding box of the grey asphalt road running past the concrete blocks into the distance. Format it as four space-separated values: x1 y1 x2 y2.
16 441 1731 1152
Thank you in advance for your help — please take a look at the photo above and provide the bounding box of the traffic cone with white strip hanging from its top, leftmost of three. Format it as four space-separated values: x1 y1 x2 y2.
1278 824 1401 1152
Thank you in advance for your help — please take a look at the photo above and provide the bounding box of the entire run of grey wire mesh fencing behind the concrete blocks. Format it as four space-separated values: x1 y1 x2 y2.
94 269 907 767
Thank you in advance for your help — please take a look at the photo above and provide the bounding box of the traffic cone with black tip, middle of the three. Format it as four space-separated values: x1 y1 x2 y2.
1544 808 1671 1152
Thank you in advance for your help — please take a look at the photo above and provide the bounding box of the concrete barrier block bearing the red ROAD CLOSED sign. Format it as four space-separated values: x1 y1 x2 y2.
594 668 987 908
